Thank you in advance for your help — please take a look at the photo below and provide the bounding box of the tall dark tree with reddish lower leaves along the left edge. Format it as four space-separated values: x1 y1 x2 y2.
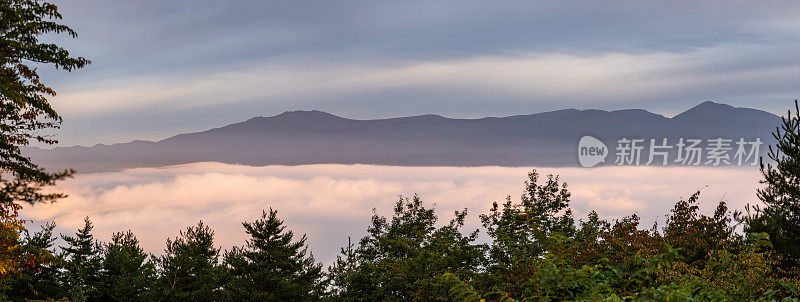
0 0 90 287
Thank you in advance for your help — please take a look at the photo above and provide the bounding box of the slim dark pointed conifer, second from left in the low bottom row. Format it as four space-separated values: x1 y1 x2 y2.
61 217 102 301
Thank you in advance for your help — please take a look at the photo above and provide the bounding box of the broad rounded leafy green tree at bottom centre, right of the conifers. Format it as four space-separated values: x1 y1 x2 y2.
329 196 486 301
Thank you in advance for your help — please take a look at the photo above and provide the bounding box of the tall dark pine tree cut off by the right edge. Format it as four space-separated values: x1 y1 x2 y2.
740 100 800 275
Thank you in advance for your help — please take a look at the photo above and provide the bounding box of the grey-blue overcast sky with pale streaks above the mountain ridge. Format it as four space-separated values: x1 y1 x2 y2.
41 0 800 145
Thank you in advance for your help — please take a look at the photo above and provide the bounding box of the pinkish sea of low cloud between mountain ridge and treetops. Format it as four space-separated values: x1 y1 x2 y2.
23 163 759 261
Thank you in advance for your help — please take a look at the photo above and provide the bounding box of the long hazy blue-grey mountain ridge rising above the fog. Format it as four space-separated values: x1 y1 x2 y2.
26 102 780 172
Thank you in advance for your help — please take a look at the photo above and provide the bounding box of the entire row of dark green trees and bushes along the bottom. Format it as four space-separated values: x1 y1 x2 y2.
2 166 800 301
